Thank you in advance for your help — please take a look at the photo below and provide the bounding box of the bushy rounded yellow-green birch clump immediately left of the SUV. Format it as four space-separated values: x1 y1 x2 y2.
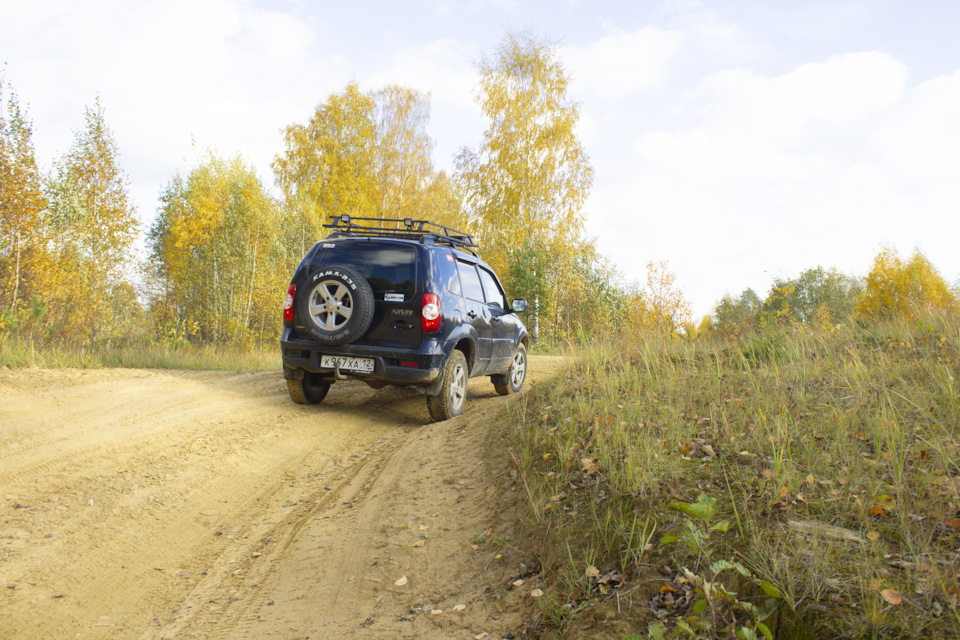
147 156 282 346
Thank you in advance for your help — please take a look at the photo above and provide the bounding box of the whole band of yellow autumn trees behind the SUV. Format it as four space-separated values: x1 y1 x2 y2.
0 33 957 360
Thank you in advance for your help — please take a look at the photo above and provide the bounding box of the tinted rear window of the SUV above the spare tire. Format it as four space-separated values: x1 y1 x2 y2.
321 242 417 300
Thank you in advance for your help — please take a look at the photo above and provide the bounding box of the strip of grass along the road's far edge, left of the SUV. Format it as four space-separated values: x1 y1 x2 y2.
0 335 281 371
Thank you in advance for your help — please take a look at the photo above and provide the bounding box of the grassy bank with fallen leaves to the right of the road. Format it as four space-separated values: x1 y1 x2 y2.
512 316 960 638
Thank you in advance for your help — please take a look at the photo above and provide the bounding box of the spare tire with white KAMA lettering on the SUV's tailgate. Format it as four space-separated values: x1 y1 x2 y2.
298 267 374 346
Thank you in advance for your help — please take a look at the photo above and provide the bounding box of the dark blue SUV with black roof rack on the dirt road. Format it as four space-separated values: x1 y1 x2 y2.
280 215 529 420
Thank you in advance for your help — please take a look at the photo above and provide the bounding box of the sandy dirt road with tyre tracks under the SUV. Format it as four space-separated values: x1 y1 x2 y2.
0 357 562 640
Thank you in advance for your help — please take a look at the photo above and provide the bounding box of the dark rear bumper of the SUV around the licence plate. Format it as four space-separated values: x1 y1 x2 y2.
280 329 444 385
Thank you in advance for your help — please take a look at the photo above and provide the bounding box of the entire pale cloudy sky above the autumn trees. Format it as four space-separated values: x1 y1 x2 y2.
0 0 960 317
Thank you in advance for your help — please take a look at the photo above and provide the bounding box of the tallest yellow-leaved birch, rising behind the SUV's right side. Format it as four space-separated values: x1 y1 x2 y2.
456 33 593 338
